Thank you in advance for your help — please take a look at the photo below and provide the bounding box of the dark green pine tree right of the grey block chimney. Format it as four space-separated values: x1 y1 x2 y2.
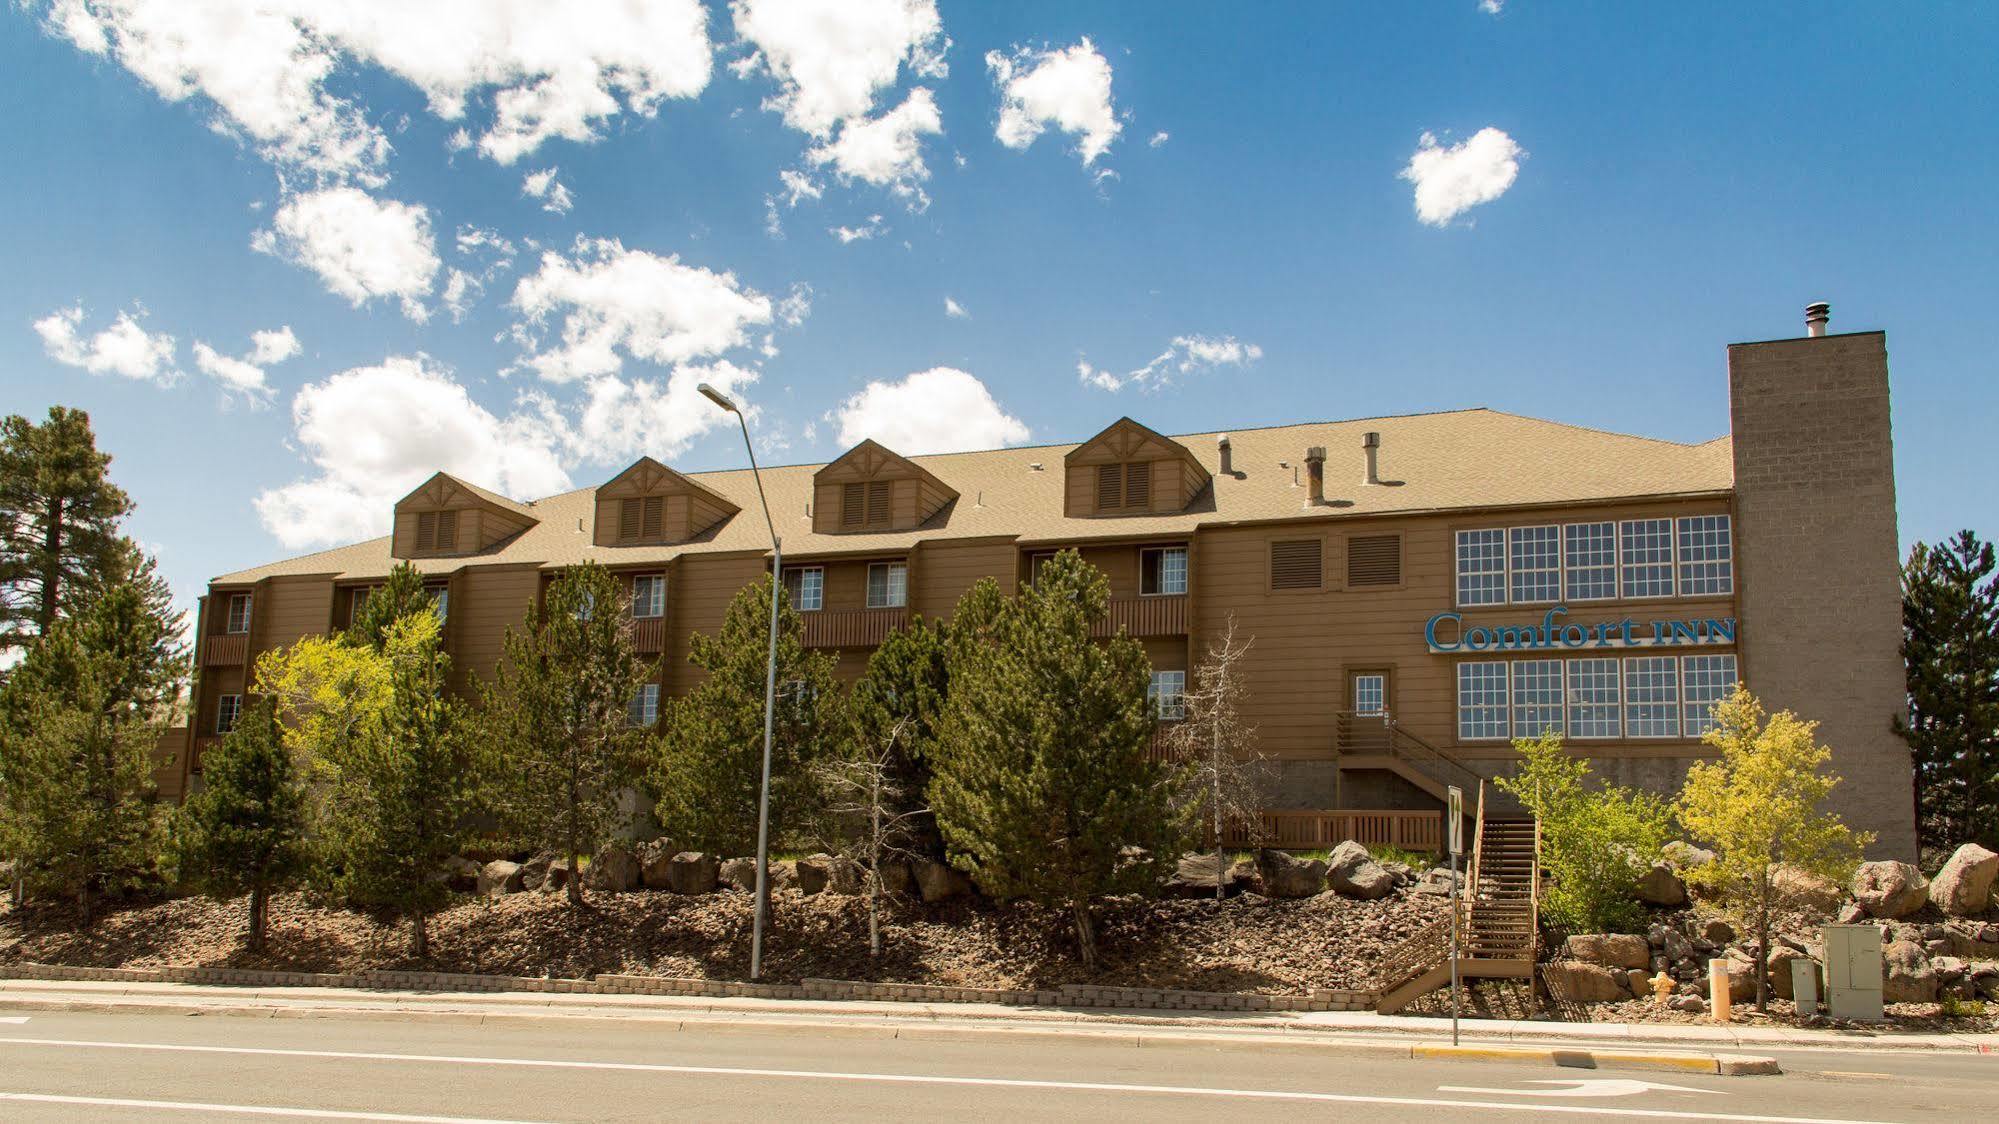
1899 530 1999 850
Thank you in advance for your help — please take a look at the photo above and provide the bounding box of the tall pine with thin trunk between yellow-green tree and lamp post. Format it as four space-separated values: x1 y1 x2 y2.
482 562 656 906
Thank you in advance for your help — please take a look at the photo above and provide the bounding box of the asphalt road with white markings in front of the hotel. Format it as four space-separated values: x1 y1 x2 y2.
0 1012 1999 1124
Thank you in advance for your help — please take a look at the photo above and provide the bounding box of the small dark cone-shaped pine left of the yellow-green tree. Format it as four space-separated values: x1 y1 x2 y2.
174 700 312 952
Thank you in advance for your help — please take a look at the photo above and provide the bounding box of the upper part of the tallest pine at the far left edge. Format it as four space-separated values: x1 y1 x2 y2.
0 406 132 650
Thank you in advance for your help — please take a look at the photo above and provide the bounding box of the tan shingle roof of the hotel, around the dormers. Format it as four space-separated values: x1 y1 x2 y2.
216 408 1735 584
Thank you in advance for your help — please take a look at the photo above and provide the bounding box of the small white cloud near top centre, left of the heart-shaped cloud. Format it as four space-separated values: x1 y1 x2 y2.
986 38 1123 166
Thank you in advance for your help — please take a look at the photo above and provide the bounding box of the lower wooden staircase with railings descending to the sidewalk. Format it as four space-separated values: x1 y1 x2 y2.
1373 784 1541 1014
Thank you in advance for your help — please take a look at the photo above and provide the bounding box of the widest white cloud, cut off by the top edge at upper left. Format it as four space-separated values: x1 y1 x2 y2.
44 0 712 186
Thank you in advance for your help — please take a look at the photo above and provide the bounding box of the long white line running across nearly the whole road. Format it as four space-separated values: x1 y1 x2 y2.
0 1038 1885 1124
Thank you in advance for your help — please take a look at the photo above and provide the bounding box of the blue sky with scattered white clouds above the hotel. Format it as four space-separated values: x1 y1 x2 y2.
0 0 1999 612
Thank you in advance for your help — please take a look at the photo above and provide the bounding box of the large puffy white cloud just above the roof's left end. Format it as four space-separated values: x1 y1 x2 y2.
256 354 570 548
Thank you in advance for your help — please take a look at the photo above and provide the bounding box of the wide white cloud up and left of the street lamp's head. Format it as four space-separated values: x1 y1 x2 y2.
512 238 774 382
